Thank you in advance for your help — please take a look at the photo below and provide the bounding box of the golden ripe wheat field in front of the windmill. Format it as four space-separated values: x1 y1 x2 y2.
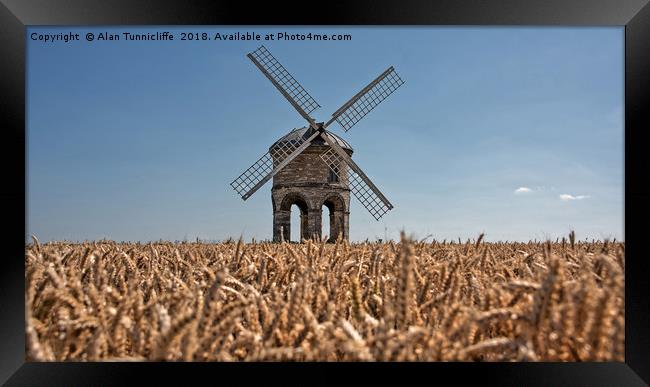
25 233 625 361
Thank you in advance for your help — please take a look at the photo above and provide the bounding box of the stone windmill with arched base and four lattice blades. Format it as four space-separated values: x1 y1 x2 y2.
230 46 404 241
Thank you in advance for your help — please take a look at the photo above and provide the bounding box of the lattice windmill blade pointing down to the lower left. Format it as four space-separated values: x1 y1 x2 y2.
230 131 319 200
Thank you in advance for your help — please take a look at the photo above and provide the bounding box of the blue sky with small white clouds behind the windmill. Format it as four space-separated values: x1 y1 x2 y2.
26 27 624 241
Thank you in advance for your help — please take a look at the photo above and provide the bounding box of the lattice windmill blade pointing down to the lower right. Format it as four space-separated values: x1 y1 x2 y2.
320 131 393 220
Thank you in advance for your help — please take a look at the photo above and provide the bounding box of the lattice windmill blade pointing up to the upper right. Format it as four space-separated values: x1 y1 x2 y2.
324 66 404 132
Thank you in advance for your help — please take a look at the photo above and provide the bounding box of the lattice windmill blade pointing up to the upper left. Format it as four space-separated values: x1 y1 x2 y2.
246 46 320 129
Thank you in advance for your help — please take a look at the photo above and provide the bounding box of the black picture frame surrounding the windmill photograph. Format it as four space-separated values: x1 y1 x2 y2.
0 0 650 386
